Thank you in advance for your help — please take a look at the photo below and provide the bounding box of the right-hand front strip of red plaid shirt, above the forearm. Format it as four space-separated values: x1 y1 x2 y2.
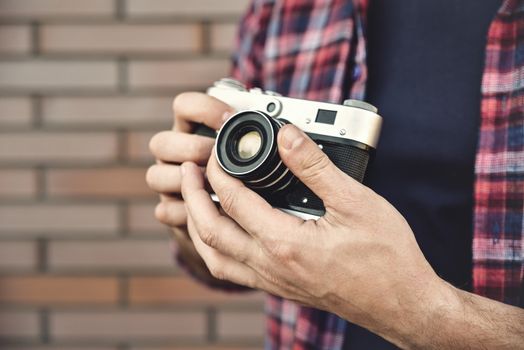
473 0 524 306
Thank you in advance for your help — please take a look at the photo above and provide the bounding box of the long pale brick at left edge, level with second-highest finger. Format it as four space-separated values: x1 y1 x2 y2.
0 132 118 165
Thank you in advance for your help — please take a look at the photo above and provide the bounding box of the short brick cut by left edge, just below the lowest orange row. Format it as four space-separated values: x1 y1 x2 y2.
0 311 40 338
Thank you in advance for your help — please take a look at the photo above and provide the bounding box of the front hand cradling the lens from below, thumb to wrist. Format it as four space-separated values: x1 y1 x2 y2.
182 125 524 347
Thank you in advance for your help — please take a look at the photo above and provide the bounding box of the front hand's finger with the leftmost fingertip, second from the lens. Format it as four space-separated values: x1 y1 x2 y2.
182 163 258 263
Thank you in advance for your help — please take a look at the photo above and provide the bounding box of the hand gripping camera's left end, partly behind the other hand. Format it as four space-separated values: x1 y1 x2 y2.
146 92 235 287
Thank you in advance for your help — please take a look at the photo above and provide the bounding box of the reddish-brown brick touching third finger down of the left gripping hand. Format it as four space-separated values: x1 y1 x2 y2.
46 168 155 198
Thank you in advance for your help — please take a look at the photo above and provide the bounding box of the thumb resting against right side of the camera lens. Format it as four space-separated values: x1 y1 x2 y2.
278 125 358 208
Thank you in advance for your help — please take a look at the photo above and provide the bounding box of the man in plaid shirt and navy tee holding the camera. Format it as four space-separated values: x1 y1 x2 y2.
148 0 524 349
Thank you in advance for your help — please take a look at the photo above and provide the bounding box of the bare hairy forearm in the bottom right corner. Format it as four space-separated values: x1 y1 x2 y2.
368 281 524 349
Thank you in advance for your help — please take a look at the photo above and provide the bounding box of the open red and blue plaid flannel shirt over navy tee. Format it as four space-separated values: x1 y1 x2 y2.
226 0 524 349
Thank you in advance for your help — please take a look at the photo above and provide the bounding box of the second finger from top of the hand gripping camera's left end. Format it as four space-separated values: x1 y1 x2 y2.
149 131 215 165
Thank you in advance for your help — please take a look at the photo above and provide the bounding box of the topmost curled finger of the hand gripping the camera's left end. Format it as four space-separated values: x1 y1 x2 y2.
173 92 234 133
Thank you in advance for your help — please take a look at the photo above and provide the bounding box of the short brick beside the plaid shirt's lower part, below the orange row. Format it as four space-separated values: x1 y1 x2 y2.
217 310 266 339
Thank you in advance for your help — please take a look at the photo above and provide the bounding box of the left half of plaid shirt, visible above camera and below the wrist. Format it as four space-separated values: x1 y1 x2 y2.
233 0 367 349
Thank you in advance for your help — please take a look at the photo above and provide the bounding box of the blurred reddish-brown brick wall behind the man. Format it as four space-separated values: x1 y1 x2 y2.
0 0 264 350
